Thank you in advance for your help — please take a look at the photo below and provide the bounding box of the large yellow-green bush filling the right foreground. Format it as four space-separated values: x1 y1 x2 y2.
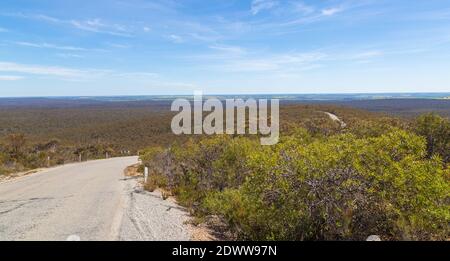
205 131 450 240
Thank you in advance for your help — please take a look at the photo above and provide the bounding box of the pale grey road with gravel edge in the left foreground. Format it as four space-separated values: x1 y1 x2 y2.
0 157 190 241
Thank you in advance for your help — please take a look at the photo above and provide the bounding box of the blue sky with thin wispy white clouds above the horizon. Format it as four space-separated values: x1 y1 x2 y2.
0 0 450 96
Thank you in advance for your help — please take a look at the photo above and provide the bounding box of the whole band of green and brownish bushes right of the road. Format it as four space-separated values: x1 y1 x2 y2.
140 111 450 240
